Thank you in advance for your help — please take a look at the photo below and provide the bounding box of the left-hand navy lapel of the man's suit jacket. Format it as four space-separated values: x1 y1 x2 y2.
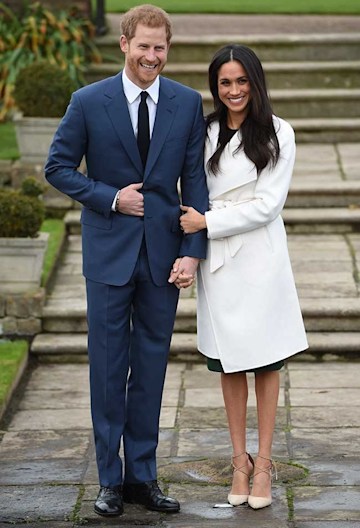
104 72 143 177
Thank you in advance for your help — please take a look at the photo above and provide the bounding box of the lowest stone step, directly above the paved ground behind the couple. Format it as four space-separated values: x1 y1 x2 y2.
31 332 360 361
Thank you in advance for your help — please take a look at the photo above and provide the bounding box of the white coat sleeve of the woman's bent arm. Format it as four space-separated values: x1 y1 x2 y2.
205 120 295 239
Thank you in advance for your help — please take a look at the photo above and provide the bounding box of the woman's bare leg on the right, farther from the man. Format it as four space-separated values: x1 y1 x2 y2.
251 370 280 497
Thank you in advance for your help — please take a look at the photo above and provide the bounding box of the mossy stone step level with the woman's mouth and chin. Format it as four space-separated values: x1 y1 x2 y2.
200 88 360 121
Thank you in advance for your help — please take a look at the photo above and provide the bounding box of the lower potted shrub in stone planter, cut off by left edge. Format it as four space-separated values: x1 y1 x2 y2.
0 177 48 293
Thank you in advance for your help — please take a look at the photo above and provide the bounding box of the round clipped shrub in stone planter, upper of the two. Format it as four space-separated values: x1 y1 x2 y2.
13 62 76 165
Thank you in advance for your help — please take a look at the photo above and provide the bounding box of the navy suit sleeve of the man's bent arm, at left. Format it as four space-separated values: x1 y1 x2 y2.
45 92 118 216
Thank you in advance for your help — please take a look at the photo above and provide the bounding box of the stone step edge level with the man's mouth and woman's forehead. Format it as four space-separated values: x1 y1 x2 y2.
86 60 360 75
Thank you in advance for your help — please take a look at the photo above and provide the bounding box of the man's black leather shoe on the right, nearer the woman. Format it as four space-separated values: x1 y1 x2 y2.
123 480 180 513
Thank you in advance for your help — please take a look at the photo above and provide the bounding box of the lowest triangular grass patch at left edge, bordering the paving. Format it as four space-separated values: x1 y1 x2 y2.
0 340 29 408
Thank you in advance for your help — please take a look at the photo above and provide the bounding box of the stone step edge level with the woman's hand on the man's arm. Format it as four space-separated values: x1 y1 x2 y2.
64 207 360 227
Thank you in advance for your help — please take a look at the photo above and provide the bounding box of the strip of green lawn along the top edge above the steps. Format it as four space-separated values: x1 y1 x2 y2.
97 0 360 14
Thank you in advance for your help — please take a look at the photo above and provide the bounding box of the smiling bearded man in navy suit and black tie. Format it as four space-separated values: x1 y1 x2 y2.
45 5 208 516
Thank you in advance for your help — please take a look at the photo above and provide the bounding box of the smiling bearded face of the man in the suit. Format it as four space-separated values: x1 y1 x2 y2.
120 24 169 90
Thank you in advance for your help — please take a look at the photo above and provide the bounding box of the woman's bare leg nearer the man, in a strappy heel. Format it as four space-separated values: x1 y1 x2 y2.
221 372 253 503
